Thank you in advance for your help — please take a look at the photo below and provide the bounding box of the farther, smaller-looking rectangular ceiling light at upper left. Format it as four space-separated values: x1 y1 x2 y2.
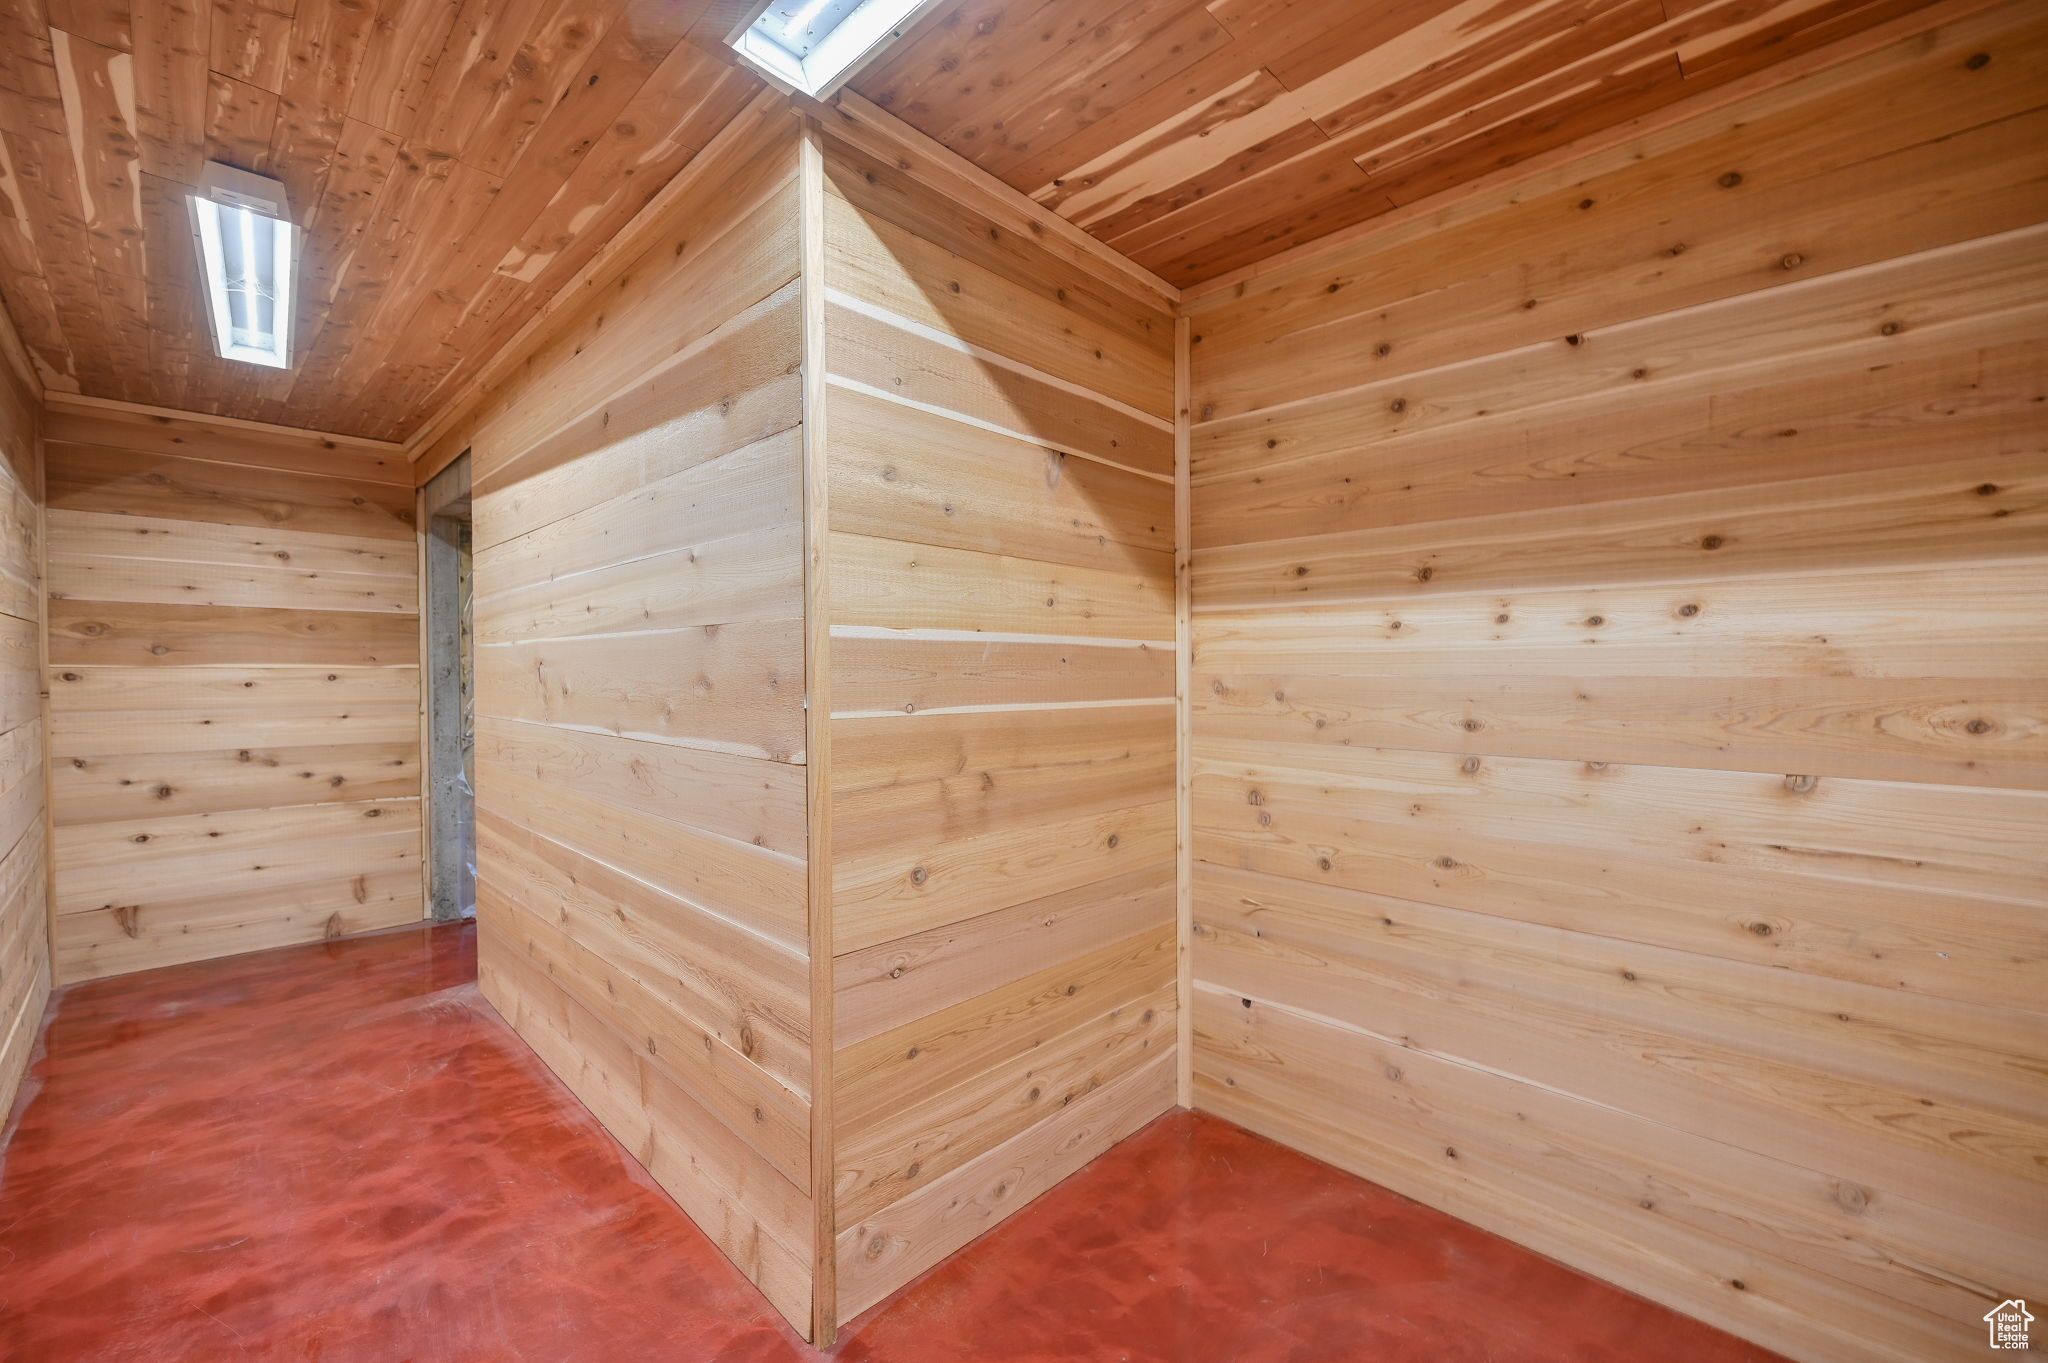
186 162 299 368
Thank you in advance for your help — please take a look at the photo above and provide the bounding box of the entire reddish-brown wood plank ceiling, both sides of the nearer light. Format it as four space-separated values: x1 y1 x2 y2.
0 0 1949 438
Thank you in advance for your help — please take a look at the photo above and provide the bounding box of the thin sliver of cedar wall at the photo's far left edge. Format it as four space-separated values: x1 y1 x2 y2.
0 345 51 1126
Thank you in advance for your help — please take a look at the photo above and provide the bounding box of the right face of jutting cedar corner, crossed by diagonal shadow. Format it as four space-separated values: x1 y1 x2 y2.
806 125 1178 1320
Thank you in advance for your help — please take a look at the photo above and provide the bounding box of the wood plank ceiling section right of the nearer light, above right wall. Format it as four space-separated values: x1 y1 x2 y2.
854 0 1949 287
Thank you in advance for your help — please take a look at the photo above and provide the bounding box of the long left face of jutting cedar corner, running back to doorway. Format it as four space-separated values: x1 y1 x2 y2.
442 104 815 1328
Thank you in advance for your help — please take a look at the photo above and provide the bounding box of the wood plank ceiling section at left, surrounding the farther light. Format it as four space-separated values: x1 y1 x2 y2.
0 0 762 438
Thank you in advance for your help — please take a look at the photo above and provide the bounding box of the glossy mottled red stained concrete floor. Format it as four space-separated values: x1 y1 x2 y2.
0 927 1774 1363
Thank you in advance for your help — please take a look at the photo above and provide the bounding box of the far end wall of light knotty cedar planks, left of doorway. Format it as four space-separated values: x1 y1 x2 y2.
43 397 422 982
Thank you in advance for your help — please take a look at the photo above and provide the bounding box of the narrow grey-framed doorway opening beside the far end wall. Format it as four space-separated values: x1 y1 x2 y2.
420 450 477 923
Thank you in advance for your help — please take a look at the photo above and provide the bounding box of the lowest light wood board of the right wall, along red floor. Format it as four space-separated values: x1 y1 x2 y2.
1198 991 2023 1359
